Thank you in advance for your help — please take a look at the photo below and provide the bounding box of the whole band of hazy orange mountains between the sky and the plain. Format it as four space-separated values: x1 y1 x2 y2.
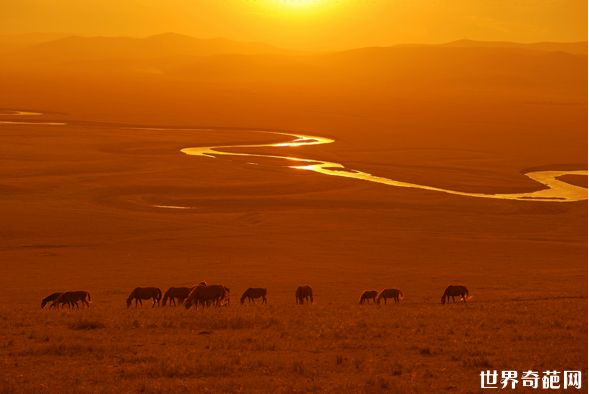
0 33 587 101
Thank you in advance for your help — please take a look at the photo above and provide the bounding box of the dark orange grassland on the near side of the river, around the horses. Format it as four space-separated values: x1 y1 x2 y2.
0 116 587 393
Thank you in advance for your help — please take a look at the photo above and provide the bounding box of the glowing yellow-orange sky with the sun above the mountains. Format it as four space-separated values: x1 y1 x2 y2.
0 0 587 49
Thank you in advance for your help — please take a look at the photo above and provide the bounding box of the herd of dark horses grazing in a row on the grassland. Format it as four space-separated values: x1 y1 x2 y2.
41 282 470 309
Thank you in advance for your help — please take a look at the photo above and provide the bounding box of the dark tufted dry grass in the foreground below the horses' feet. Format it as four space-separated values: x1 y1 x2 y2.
0 293 587 393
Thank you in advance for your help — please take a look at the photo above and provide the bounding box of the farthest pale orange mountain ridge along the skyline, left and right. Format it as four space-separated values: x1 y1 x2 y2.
0 33 587 63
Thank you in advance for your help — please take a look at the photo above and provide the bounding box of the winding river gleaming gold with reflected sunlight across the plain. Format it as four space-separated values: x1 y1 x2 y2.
0 110 587 203
